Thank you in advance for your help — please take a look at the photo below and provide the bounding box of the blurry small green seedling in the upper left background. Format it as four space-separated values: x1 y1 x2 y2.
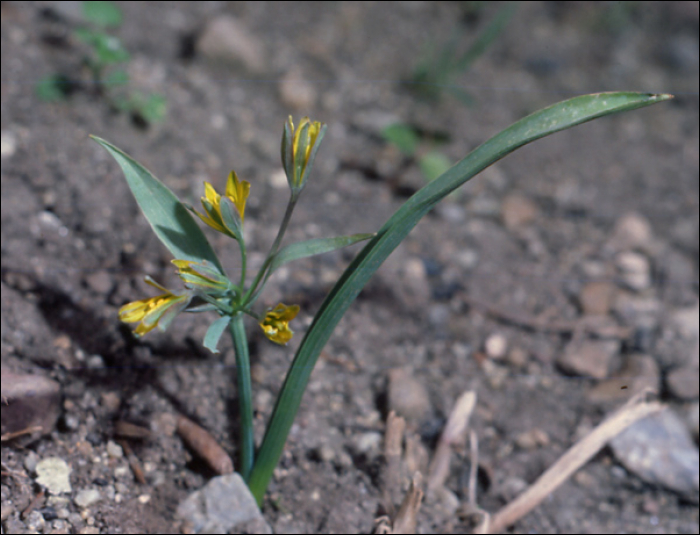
36 2 167 125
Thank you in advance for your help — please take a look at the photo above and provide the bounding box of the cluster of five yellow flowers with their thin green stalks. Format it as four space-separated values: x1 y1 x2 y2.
119 117 326 349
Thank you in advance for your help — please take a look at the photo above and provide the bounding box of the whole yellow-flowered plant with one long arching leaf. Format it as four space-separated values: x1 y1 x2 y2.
94 93 672 504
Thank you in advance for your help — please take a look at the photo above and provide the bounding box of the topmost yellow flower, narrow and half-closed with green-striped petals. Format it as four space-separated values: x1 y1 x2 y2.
282 116 326 195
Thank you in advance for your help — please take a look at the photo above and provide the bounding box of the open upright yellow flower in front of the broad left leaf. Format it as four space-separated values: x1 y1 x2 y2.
194 171 250 239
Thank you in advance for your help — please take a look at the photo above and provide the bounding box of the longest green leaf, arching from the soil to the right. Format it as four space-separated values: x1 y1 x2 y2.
248 92 672 504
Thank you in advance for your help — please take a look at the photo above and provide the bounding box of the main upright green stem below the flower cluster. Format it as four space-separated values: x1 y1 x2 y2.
230 312 255 481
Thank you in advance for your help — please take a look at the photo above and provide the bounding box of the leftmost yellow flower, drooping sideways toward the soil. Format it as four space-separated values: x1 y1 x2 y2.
119 277 192 336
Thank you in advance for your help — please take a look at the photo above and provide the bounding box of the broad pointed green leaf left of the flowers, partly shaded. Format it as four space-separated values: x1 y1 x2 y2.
90 136 225 274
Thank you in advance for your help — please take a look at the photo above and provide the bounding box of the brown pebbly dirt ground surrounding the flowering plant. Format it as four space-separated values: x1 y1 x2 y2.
0 2 699 533
